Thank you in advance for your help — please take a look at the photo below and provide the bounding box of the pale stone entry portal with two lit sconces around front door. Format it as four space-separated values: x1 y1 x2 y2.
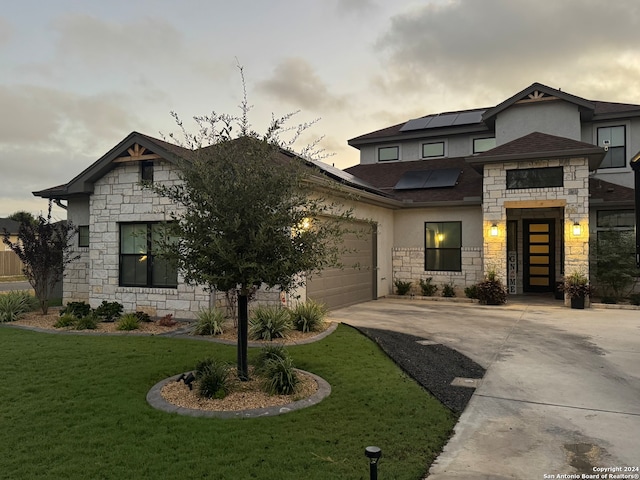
482 158 589 286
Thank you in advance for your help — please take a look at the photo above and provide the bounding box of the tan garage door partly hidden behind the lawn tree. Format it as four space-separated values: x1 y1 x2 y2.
307 219 376 309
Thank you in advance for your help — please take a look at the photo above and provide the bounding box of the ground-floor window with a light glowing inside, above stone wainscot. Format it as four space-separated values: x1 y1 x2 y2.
424 222 462 272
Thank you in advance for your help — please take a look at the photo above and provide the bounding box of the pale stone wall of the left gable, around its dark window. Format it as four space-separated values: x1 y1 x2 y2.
88 161 210 318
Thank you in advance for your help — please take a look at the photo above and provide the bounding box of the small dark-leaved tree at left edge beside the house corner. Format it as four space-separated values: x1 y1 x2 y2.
2 201 79 315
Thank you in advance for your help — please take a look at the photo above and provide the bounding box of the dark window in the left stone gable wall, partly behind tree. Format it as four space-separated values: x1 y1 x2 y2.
120 223 178 288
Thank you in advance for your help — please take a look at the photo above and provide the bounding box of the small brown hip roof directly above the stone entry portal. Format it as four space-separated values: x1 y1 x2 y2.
467 132 606 170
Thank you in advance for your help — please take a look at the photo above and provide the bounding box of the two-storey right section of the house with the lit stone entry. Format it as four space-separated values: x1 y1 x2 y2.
347 83 640 300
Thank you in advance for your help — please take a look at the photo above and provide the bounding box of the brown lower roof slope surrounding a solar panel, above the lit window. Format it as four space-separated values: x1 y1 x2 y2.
345 157 482 204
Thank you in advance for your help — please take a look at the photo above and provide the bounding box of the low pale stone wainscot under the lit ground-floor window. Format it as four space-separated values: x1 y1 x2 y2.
392 247 483 296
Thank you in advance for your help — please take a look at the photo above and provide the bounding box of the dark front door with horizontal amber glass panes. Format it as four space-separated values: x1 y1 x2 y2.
522 219 555 292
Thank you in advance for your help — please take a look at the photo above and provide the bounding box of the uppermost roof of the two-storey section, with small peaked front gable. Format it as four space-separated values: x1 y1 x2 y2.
348 83 640 148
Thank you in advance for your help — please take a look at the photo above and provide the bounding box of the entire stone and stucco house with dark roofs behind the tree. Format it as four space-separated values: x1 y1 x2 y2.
34 83 640 317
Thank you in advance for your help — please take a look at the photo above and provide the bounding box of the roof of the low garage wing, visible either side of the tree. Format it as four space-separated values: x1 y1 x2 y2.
33 132 386 199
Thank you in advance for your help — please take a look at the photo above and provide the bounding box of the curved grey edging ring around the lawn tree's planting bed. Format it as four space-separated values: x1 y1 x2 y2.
147 368 331 418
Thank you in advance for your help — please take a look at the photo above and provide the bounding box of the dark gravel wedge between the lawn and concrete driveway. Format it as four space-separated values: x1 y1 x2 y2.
354 327 485 413
